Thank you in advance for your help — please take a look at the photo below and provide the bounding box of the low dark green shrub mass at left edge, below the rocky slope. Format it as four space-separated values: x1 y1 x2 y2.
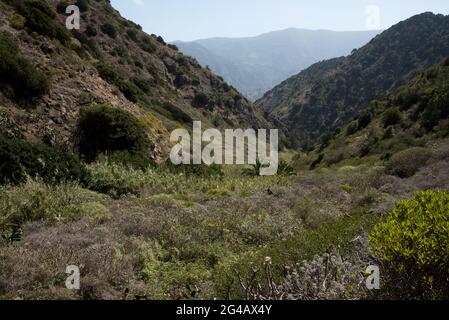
0 138 87 184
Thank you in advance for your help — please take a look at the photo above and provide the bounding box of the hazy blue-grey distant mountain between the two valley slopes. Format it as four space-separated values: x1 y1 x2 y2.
174 29 379 100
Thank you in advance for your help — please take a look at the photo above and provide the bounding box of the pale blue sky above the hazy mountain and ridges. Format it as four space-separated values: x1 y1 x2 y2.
111 0 449 41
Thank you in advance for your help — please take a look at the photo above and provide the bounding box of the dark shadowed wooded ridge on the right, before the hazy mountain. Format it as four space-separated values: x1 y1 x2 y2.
256 12 449 148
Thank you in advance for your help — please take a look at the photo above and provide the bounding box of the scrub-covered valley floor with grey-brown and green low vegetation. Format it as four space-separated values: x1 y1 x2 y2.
0 140 449 299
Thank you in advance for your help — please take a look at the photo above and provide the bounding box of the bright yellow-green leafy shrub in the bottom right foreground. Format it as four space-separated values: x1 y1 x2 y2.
370 191 449 299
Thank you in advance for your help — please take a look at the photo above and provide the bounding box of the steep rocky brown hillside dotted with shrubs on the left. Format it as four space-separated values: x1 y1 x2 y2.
0 0 268 160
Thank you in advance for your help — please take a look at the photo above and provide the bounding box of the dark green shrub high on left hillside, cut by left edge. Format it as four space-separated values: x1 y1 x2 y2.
0 33 50 100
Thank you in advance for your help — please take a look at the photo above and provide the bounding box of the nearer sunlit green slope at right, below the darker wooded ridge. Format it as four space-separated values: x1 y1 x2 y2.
303 58 449 170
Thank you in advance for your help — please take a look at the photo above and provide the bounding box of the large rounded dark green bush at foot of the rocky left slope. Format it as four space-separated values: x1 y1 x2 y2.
78 105 149 162
